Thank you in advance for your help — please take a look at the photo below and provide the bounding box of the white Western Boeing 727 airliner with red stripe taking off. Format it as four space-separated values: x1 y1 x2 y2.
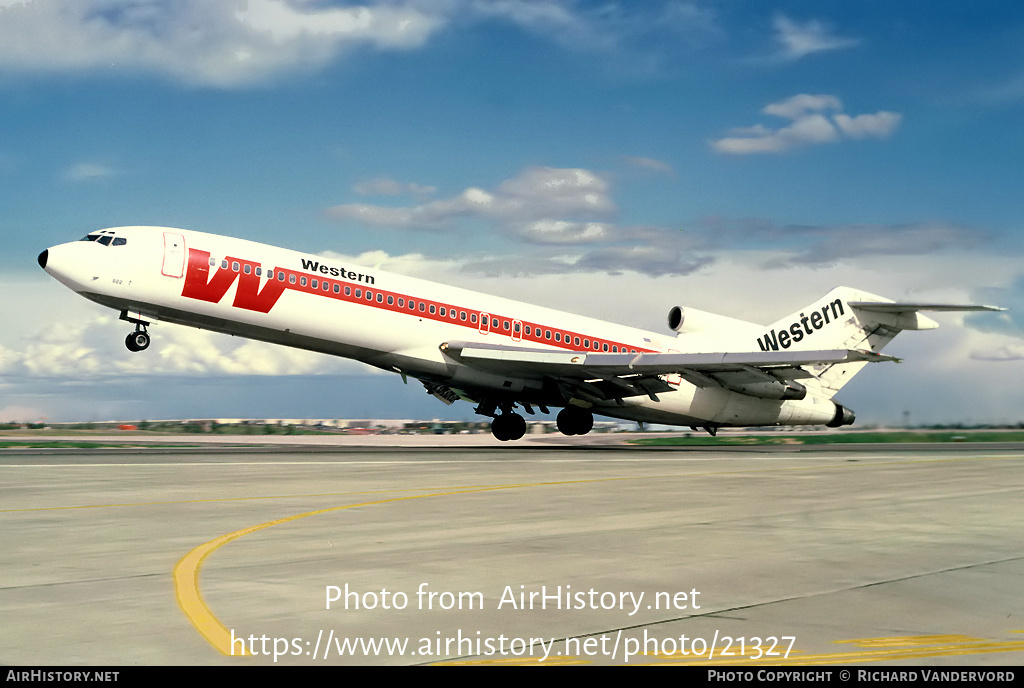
39 226 997 440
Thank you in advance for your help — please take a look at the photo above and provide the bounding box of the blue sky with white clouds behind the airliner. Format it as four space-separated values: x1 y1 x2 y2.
0 0 1024 422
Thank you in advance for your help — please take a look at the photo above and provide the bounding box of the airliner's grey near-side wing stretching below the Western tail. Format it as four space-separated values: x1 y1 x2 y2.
441 342 898 401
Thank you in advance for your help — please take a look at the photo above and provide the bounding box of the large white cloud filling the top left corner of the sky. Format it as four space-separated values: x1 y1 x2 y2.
0 0 446 87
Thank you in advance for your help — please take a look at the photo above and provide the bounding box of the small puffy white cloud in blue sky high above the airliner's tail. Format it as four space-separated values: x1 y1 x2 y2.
711 93 902 156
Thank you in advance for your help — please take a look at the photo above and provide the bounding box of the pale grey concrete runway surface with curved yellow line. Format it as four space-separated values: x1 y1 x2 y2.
0 437 1024 665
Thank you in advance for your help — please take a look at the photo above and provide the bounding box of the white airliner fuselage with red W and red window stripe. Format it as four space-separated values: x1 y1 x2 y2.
40 227 836 426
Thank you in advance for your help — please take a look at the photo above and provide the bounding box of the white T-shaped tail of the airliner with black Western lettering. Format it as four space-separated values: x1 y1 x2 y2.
757 287 1000 398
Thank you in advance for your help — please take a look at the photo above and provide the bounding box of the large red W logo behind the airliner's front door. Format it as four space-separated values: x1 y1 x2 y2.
181 249 286 313
